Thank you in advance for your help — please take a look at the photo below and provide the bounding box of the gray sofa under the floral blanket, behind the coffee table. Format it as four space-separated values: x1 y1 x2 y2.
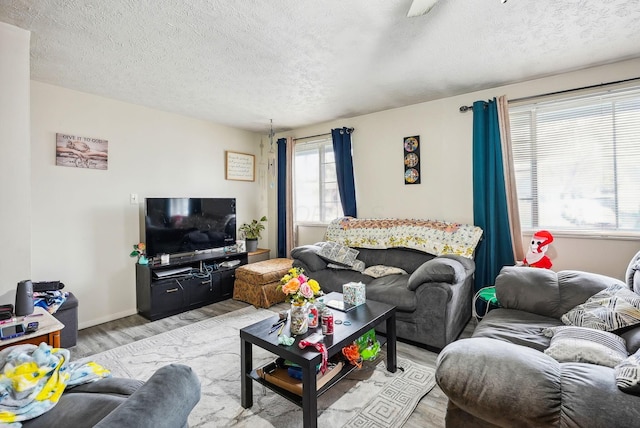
291 243 475 350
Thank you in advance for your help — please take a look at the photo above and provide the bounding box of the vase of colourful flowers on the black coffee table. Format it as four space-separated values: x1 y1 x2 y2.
280 267 323 335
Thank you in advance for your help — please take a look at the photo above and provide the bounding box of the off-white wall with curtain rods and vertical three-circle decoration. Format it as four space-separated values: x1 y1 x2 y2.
286 60 640 279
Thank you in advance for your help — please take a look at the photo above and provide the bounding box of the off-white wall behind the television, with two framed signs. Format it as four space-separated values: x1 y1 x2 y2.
30 82 263 327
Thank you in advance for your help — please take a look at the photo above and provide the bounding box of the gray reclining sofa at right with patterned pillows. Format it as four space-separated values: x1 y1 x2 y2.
436 266 640 428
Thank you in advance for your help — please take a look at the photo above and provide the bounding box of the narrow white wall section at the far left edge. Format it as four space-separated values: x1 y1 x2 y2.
0 22 31 303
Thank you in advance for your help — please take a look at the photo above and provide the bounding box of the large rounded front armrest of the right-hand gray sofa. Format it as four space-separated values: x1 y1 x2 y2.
436 338 562 427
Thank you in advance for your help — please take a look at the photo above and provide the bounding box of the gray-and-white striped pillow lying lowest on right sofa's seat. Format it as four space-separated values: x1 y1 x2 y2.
544 326 628 367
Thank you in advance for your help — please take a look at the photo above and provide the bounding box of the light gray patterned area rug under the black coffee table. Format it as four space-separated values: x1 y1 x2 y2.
81 307 435 428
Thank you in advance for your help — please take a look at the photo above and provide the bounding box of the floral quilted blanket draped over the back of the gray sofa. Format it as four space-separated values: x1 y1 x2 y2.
325 217 482 258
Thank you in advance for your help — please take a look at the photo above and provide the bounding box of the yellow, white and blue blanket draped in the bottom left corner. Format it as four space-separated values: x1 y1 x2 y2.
0 342 111 427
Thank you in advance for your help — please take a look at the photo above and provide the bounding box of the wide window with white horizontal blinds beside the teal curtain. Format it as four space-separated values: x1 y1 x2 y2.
509 88 640 235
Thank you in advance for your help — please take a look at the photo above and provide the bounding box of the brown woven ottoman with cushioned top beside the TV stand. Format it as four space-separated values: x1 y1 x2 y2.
233 259 293 308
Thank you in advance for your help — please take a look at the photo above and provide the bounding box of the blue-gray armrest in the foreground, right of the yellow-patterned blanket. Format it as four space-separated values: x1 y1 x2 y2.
96 364 200 428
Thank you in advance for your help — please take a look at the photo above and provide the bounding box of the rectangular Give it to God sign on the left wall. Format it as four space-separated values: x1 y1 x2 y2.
56 133 109 169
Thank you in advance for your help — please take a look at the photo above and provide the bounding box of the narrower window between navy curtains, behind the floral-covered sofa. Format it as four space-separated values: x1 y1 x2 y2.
293 138 343 223
